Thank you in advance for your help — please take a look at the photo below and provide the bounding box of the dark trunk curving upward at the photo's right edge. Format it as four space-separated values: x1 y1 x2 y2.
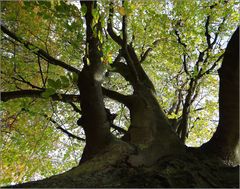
202 28 240 165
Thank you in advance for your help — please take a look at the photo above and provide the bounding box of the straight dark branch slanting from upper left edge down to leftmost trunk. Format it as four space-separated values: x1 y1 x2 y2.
1 24 80 74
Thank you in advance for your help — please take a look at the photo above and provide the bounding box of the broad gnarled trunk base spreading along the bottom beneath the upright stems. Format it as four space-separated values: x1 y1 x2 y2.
7 142 239 188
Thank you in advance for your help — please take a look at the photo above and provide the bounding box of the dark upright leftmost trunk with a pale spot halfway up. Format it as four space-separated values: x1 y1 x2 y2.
78 1 113 163
